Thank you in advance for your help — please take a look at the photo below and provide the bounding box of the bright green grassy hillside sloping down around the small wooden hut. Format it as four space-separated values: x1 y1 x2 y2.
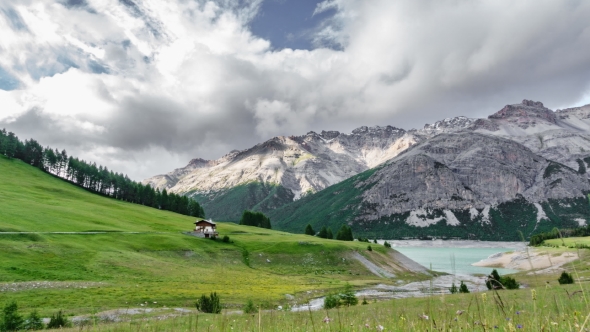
0 157 414 315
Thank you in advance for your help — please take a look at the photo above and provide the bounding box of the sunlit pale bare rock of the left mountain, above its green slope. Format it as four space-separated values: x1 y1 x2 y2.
144 126 416 199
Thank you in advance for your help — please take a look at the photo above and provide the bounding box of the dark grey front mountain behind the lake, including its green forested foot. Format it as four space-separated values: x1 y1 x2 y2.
271 131 590 240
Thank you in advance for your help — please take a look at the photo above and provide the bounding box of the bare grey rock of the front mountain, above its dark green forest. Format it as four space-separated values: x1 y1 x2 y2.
360 131 590 220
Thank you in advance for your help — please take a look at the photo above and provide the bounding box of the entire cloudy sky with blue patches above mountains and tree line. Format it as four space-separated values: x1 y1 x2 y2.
0 0 590 180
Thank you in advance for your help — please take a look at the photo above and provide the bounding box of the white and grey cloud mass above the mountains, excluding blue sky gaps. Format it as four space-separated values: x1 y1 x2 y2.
0 0 590 182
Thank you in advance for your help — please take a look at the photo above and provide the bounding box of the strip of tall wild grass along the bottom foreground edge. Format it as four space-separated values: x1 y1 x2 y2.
47 285 590 332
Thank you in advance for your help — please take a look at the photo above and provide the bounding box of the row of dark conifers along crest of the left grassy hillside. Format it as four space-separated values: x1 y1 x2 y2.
0 129 205 218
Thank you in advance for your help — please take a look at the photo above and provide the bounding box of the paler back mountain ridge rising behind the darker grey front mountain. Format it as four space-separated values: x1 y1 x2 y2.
144 100 590 220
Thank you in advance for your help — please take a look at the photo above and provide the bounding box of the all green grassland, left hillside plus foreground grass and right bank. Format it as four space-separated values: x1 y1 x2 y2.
0 156 590 331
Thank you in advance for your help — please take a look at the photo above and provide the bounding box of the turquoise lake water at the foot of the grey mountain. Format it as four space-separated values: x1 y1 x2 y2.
389 241 523 275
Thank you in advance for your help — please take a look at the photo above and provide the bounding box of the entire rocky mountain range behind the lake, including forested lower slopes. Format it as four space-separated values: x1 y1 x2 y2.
144 100 590 239
